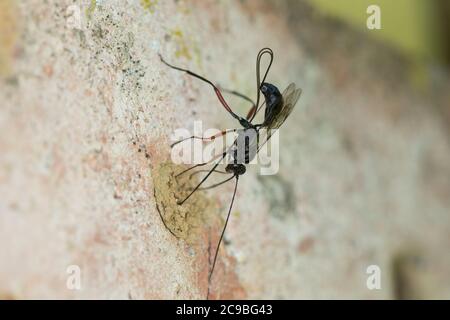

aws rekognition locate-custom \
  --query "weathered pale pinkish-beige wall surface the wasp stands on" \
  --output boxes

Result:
[0,1,450,299]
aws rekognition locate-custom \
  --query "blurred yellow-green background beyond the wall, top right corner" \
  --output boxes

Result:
[307,0,450,88]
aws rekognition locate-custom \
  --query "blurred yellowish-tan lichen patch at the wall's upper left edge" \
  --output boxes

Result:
[0,0,18,77]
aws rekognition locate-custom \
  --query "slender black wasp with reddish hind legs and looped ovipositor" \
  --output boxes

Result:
[160,48,302,296]
